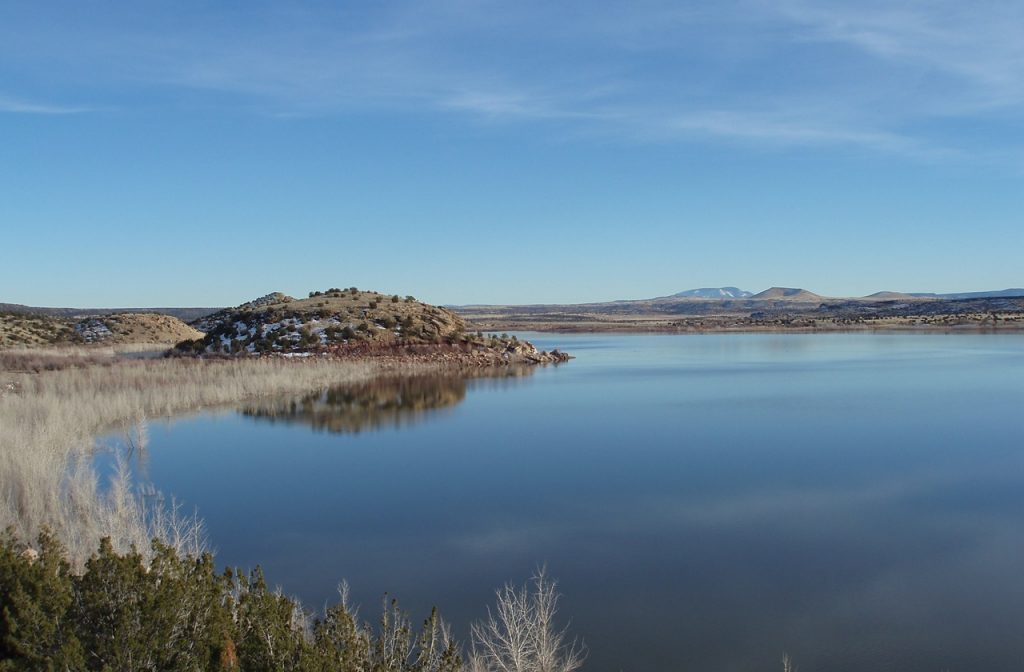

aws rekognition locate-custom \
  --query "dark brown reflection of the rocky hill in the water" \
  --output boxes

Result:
[240,369,529,433]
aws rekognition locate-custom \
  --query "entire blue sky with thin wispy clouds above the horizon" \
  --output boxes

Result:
[0,0,1024,306]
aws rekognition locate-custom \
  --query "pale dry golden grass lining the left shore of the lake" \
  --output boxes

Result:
[0,348,426,563]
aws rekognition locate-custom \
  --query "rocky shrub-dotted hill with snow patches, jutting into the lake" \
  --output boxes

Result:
[177,287,567,364]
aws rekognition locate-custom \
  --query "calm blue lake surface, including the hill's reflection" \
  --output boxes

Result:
[110,334,1024,672]
